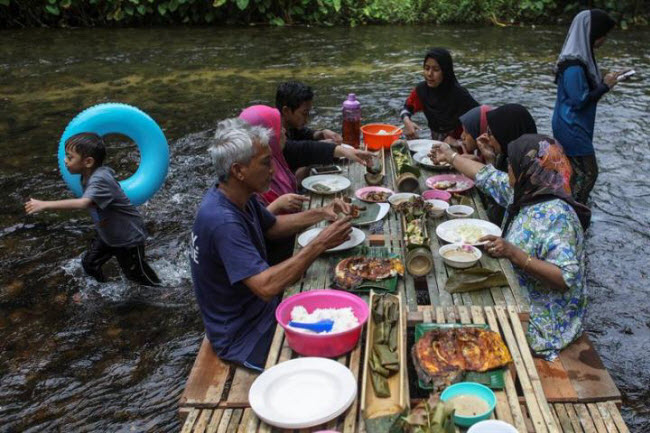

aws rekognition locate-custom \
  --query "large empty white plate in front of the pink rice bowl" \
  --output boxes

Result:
[248,358,357,429]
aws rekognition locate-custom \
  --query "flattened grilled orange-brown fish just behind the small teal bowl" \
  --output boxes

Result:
[411,327,512,389]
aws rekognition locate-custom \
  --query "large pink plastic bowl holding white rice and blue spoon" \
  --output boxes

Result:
[275,289,368,358]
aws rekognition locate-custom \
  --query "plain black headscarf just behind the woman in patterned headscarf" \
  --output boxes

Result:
[486,104,537,155]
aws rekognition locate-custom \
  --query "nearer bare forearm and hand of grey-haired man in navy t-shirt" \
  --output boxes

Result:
[242,217,352,301]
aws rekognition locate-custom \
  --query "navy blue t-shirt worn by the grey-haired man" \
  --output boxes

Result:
[190,187,278,364]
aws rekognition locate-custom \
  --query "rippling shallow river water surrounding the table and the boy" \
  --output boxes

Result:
[0,26,650,432]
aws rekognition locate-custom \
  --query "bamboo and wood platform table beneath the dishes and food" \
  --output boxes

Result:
[179,150,628,433]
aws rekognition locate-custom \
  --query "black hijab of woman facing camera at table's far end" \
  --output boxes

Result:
[415,48,478,133]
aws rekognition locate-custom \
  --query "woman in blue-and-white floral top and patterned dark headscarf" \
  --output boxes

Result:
[434,134,591,361]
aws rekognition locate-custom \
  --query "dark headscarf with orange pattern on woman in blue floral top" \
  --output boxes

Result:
[503,134,591,236]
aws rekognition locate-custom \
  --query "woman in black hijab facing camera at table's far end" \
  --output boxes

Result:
[400,48,479,140]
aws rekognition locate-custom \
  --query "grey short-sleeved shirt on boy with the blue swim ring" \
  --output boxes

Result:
[82,166,147,247]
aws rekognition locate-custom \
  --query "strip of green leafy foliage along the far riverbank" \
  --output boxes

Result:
[0,0,650,28]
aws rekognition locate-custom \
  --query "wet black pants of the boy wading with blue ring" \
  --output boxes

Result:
[81,237,160,286]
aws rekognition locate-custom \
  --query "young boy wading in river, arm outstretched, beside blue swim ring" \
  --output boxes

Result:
[25,133,160,286]
